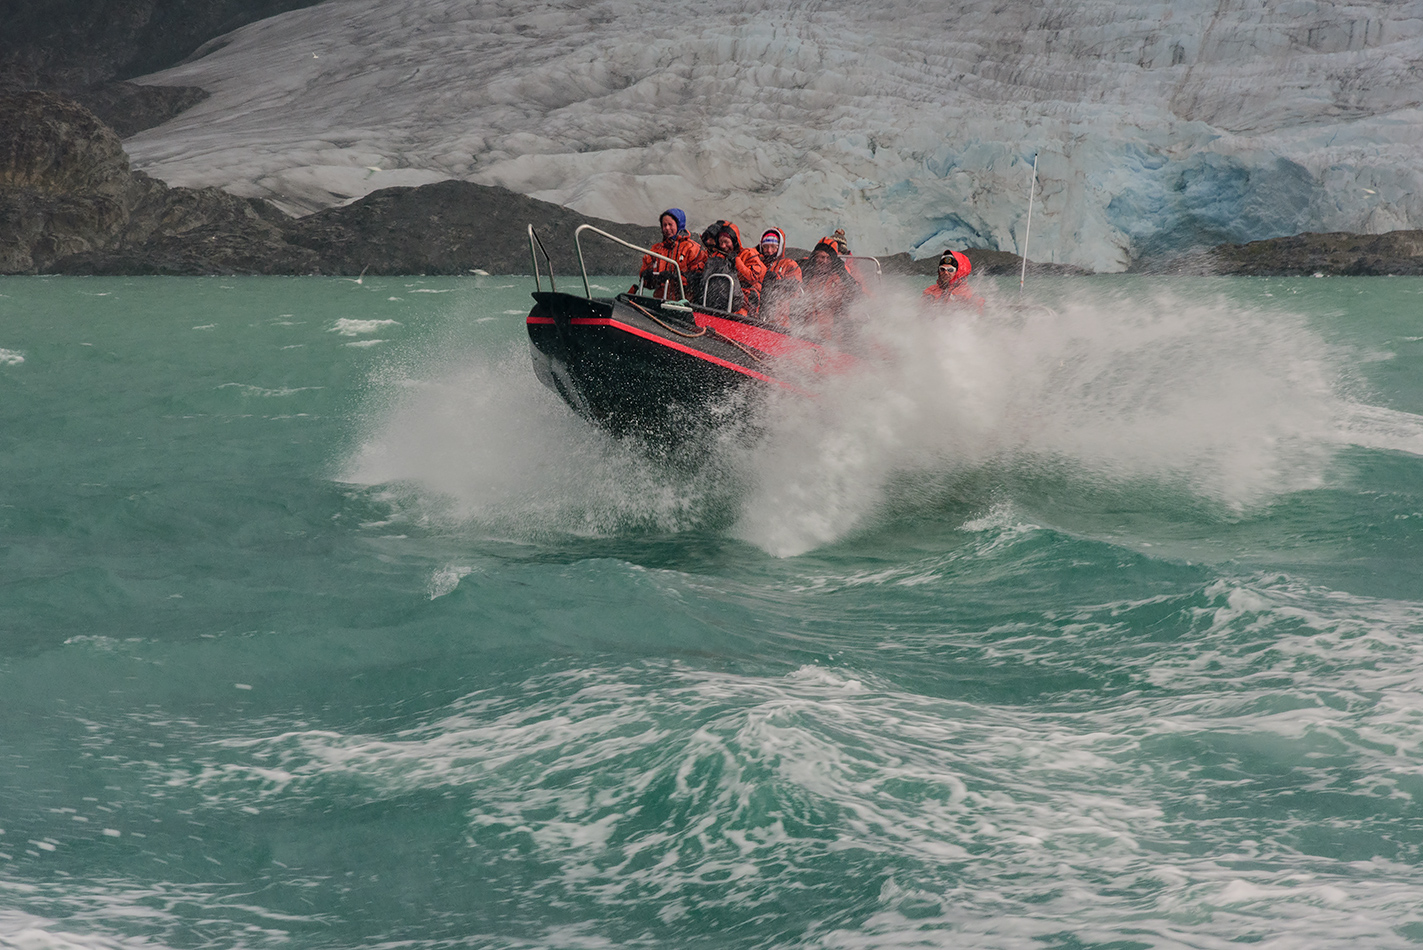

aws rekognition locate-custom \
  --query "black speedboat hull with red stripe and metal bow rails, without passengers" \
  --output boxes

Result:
[528,225,854,441]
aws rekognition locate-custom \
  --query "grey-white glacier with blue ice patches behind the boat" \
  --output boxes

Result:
[125,0,1423,272]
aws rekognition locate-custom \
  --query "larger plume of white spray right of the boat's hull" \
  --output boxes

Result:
[737,278,1342,555]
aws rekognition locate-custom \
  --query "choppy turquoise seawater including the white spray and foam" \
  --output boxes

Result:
[0,277,1423,950]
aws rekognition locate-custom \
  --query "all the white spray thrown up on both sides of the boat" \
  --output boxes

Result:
[346,284,1345,556]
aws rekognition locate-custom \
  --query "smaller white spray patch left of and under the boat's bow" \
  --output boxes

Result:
[334,341,734,539]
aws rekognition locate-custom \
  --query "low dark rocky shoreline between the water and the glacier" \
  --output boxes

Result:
[0,91,1423,276]
